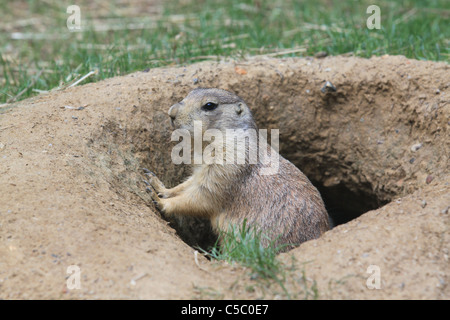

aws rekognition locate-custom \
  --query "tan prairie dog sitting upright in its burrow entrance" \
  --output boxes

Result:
[147,88,329,247]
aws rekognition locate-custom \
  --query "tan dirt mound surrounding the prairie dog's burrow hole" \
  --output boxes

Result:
[0,56,450,299]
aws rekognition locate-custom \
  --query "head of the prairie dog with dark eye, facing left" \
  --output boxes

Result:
[169,88,256,133]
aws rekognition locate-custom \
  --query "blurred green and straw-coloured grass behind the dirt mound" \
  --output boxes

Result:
[0,0,450,103]
